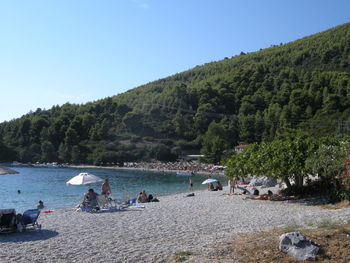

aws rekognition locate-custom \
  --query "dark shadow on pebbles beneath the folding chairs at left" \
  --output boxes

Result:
[0,229,58,244]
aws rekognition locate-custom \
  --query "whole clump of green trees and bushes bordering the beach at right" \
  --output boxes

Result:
[225,136,350,201]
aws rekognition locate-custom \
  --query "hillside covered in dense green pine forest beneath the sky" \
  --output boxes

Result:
[0,23,350,164]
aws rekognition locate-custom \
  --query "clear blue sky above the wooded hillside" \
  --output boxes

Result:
[0,0,350,122]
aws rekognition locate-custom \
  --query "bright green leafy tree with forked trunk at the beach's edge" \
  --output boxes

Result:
[227,137,315,191]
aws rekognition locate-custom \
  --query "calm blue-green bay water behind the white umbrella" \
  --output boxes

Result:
[0,167,224,213]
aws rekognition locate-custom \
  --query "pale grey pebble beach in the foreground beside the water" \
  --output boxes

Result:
[0,189,350,262]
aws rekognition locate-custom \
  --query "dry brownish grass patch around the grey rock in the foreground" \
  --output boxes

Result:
[178,221,350,263]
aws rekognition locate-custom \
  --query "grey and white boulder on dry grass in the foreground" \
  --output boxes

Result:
[279,232,319,261]
